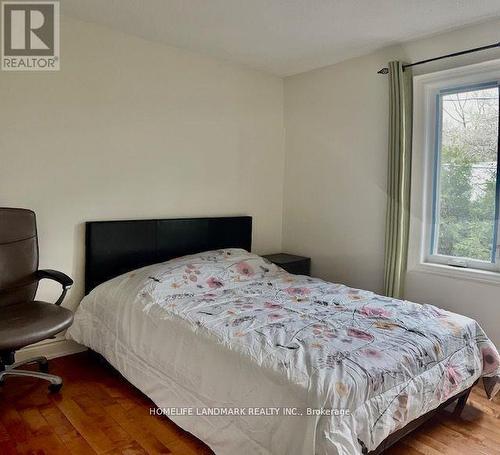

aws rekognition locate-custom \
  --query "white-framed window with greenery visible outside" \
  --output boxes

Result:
[408,60,500,284]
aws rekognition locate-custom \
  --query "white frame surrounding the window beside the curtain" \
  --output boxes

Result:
[408,60,500,285]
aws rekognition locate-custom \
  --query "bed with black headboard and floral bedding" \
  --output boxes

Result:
[67,217,500,455]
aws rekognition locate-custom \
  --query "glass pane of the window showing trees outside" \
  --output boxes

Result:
[433,87,499,262]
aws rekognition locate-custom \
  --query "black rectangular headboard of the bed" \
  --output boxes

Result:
[85,216,252,294]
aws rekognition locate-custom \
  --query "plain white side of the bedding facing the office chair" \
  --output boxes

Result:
[67,268,320,455]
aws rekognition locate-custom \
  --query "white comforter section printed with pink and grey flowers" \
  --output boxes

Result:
[70,249,500,454]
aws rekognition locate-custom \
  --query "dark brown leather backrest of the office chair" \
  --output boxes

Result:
[0,207,38,307]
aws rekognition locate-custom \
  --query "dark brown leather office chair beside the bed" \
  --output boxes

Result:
[0,208,73,392]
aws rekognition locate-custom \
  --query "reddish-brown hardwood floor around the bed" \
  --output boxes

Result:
[0,353,500,455]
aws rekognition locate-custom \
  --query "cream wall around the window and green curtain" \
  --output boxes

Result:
[283,16,500,345]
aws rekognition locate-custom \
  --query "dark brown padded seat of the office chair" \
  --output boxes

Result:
[0,300,73,351]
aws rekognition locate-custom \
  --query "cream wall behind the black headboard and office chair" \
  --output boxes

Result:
[0,18,284,356]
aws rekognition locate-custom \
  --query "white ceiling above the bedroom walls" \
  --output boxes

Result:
[61,0,500,76]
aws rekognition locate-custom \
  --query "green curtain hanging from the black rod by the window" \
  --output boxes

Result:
[384,62,412,298]
